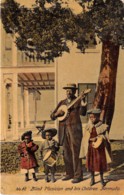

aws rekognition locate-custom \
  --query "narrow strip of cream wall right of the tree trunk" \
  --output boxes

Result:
[110,50,124,139]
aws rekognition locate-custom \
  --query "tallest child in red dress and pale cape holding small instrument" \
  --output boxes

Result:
[80,109,111,187]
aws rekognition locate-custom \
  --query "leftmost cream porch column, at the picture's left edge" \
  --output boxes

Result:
[0,73,7,141]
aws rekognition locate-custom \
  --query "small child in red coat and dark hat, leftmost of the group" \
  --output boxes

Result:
[18,131,38,181]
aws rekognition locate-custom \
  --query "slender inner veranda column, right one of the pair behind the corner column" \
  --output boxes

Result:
[24,89,30,127]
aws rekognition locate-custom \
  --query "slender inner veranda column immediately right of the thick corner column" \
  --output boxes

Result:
[20,86,24,128]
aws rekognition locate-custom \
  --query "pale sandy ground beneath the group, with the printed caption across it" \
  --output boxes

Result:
[1,141,124,195]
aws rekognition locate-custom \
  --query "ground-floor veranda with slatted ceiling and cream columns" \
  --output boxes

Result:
[1,66,56,140]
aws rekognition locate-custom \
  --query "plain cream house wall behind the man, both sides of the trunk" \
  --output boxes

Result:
[56,44,124,139]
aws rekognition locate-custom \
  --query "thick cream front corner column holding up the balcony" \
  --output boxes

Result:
[12,73,19,140]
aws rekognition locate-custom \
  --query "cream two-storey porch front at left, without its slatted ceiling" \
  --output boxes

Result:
[0,25,55,141]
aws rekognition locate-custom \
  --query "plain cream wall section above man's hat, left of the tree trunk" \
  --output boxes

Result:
[58,44,101,100]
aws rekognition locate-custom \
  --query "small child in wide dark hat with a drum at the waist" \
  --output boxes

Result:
[41,128,59,182]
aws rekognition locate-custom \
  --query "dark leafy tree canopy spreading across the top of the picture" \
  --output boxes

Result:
[1,0,124,60]
